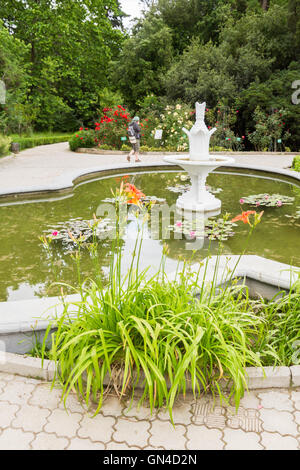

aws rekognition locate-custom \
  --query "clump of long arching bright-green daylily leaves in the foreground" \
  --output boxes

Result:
[44,206,264,416]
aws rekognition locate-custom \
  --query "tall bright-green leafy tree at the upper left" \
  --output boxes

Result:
[0,0,123,128]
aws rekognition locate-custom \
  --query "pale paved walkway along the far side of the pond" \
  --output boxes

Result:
[0,143,293,195]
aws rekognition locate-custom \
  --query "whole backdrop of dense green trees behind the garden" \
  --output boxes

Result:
[0,0,300,151]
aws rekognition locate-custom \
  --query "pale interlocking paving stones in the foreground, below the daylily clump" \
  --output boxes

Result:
[0,373,300,450]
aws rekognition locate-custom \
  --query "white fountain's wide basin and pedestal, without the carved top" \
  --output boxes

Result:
[164,155,234,217]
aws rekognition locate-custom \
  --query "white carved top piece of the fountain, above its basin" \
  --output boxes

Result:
[182,102,217,160]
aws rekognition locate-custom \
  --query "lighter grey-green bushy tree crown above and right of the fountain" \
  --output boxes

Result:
[164,5,293,106]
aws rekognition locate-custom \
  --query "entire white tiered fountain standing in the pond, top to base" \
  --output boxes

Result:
[164,103,234,217]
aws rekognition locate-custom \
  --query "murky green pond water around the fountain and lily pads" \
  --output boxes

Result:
[0,170,300,301]
